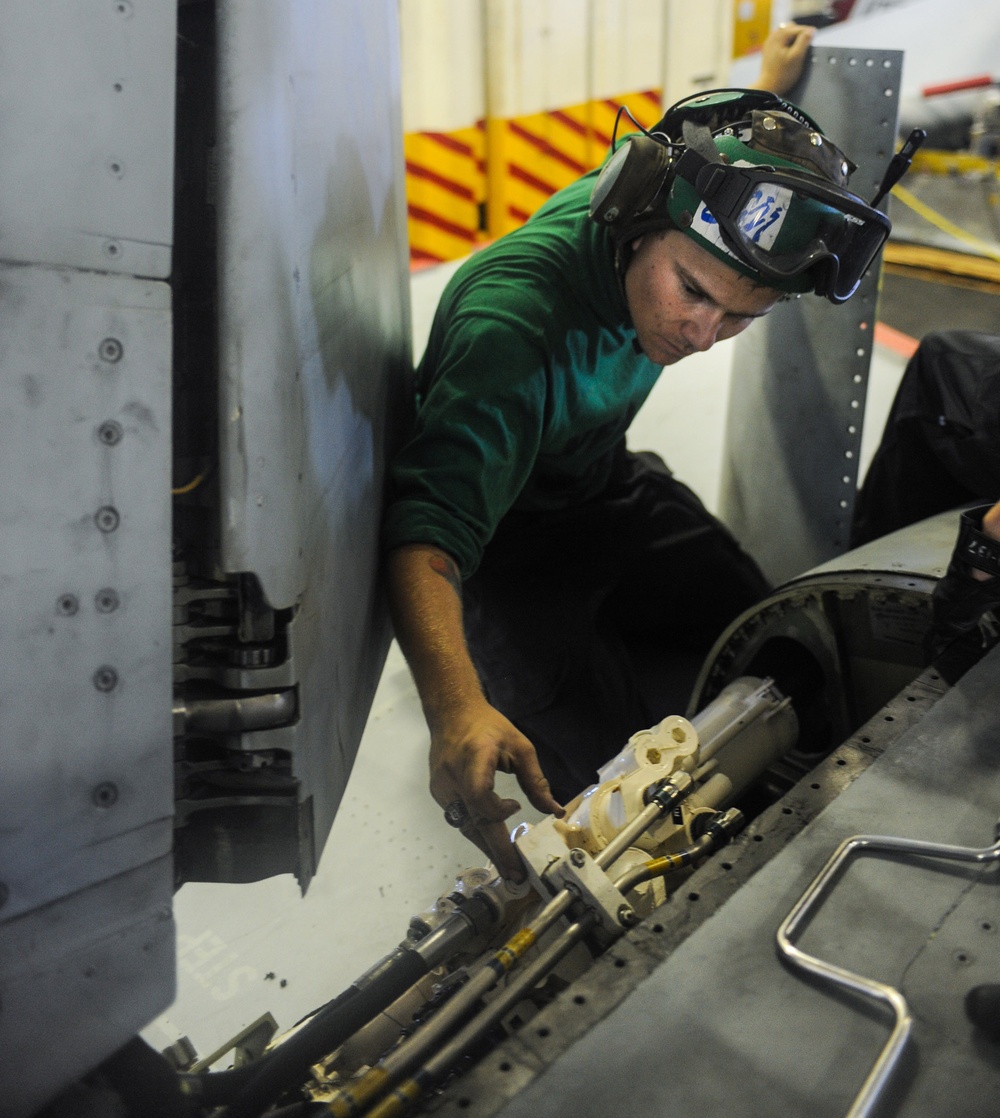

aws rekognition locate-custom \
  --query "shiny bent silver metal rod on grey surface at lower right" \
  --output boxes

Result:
[777,822,1000,1118]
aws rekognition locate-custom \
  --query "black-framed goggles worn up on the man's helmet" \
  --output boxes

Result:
[676,148,891,303]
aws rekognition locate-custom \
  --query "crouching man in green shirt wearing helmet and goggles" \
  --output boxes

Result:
[384,81,888,878]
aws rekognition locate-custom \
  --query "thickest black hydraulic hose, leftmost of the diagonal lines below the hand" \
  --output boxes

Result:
[214,890,498,1118]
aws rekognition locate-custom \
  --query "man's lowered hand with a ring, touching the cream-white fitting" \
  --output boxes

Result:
[431,699,563,881]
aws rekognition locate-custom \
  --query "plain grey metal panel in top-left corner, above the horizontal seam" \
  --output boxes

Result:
[0,0,177,277]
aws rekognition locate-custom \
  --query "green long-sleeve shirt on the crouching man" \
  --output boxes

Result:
[384,174,662,577]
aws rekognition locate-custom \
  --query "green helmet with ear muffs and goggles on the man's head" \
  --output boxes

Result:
[589,89,894,303]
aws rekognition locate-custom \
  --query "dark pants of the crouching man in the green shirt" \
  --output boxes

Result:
[463,447,768,802]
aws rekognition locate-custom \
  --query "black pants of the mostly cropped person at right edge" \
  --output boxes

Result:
[851,330,1000,547]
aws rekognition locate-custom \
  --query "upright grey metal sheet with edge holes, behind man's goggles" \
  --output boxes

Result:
[720,47,903,582]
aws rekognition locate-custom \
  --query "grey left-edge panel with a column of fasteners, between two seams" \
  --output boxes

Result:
[0,268,172,917]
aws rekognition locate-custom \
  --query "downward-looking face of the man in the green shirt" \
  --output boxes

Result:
[625,229,781,364]
